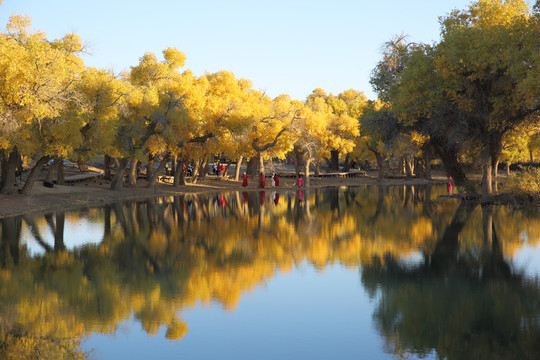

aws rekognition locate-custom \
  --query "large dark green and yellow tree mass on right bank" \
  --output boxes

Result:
[363,0,540,200]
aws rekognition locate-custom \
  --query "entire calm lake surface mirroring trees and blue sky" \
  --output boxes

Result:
[0,186,540,359]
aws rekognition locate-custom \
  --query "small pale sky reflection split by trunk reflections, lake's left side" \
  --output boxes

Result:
[21,216,103,256]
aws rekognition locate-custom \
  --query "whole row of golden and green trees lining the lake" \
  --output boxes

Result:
[0,0,540,194]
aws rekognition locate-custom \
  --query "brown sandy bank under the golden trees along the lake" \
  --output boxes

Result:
[0,169,456,218]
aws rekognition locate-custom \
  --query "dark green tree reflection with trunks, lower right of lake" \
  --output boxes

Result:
[362,203,540,359]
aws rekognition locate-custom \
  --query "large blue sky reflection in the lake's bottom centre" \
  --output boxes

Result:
[83,261,402,360]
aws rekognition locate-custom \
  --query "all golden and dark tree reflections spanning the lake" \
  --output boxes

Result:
[0,186,540,358]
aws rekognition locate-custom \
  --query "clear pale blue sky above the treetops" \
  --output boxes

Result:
[0,0,470,100]
